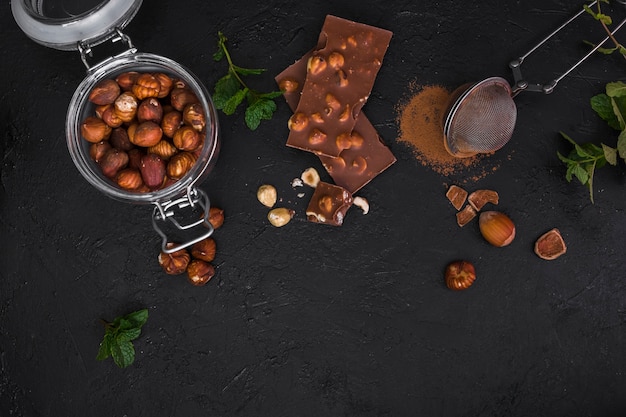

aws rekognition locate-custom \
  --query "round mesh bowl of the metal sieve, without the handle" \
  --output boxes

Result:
[444,77,517,157]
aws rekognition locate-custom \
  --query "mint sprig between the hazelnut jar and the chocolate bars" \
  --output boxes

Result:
[213,32,283,130]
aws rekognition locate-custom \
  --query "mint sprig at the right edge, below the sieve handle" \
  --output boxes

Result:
[557,81,626,203]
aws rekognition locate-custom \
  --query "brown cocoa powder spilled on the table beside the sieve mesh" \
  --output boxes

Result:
[397,83,496,181]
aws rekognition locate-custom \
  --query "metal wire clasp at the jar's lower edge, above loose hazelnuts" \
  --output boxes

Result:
[152,188,214,253]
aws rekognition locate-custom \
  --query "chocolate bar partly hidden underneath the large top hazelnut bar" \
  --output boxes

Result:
[276,17,396,194]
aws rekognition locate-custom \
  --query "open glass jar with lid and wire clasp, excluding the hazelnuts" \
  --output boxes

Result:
[11,0,220,253]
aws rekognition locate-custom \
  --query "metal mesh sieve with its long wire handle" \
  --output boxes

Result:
[443,0,626,158]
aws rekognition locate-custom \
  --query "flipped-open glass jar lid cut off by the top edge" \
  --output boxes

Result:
[11,0,142,51]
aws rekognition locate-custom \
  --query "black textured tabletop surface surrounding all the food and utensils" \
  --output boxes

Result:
[0,0,626,417]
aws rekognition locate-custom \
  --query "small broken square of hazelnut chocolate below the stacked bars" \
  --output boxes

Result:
[306,181,353,226]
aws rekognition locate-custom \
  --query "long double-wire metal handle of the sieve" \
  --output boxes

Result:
[509,0,626,97]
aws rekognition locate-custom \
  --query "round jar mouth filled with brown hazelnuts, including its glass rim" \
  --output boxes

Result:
[66,53,219,203]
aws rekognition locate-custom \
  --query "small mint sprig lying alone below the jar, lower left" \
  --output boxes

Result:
[96,309,148,368]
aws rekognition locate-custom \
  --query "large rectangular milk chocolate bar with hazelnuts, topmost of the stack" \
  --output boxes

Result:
[287,15,392,157]
